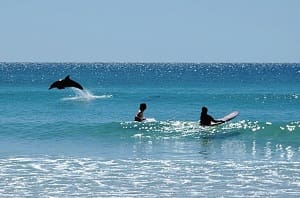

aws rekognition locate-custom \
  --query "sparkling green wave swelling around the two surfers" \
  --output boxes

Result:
[121,120,300,139]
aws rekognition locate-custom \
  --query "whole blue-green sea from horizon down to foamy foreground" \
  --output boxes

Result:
[0,63,300,197]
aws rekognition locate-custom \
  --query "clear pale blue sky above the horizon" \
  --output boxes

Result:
[0,0,300,63]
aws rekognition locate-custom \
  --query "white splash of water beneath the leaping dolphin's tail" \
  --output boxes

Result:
[62,88,112,101]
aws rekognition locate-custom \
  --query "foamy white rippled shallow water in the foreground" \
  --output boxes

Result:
[0,157,300,197]
